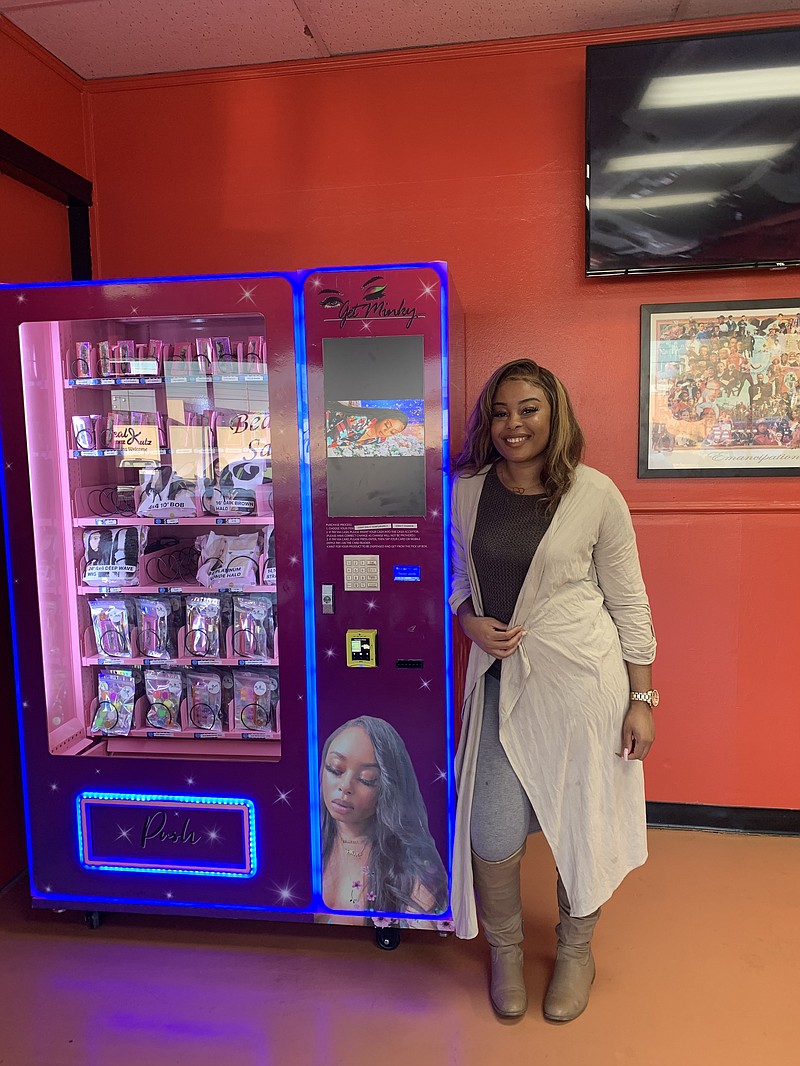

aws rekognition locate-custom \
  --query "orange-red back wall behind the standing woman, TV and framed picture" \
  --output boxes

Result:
[83,16,800,808]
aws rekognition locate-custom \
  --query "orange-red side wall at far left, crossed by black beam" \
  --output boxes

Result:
[0,18,89,887]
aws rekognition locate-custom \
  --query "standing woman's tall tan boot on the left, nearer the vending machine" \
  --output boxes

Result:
[473,844,528,1018]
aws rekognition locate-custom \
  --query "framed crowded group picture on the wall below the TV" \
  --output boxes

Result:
[639,297,800,478]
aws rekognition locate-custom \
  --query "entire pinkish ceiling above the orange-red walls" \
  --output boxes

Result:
[0,0,800,79]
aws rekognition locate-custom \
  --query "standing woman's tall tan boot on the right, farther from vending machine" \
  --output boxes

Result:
[544,874,601,1021]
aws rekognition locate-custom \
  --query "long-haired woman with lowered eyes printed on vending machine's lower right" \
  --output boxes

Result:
[320,715,454,915]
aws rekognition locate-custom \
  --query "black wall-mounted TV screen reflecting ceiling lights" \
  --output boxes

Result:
[586,28,800,276]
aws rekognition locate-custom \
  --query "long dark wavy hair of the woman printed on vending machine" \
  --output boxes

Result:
[320,715,454,915]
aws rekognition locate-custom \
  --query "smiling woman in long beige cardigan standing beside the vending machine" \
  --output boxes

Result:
[450,359,658,1021]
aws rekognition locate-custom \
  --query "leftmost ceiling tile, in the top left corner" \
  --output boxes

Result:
[0,0,320,78]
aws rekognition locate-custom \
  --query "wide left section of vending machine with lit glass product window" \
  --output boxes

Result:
[0,275,314,924]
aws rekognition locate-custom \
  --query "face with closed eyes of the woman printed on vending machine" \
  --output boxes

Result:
[322,726,381,836]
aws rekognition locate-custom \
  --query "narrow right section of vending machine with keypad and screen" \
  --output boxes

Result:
[303,263,458,948]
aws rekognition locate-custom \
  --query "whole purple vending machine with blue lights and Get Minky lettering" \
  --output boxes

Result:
[0,263,455,948]
